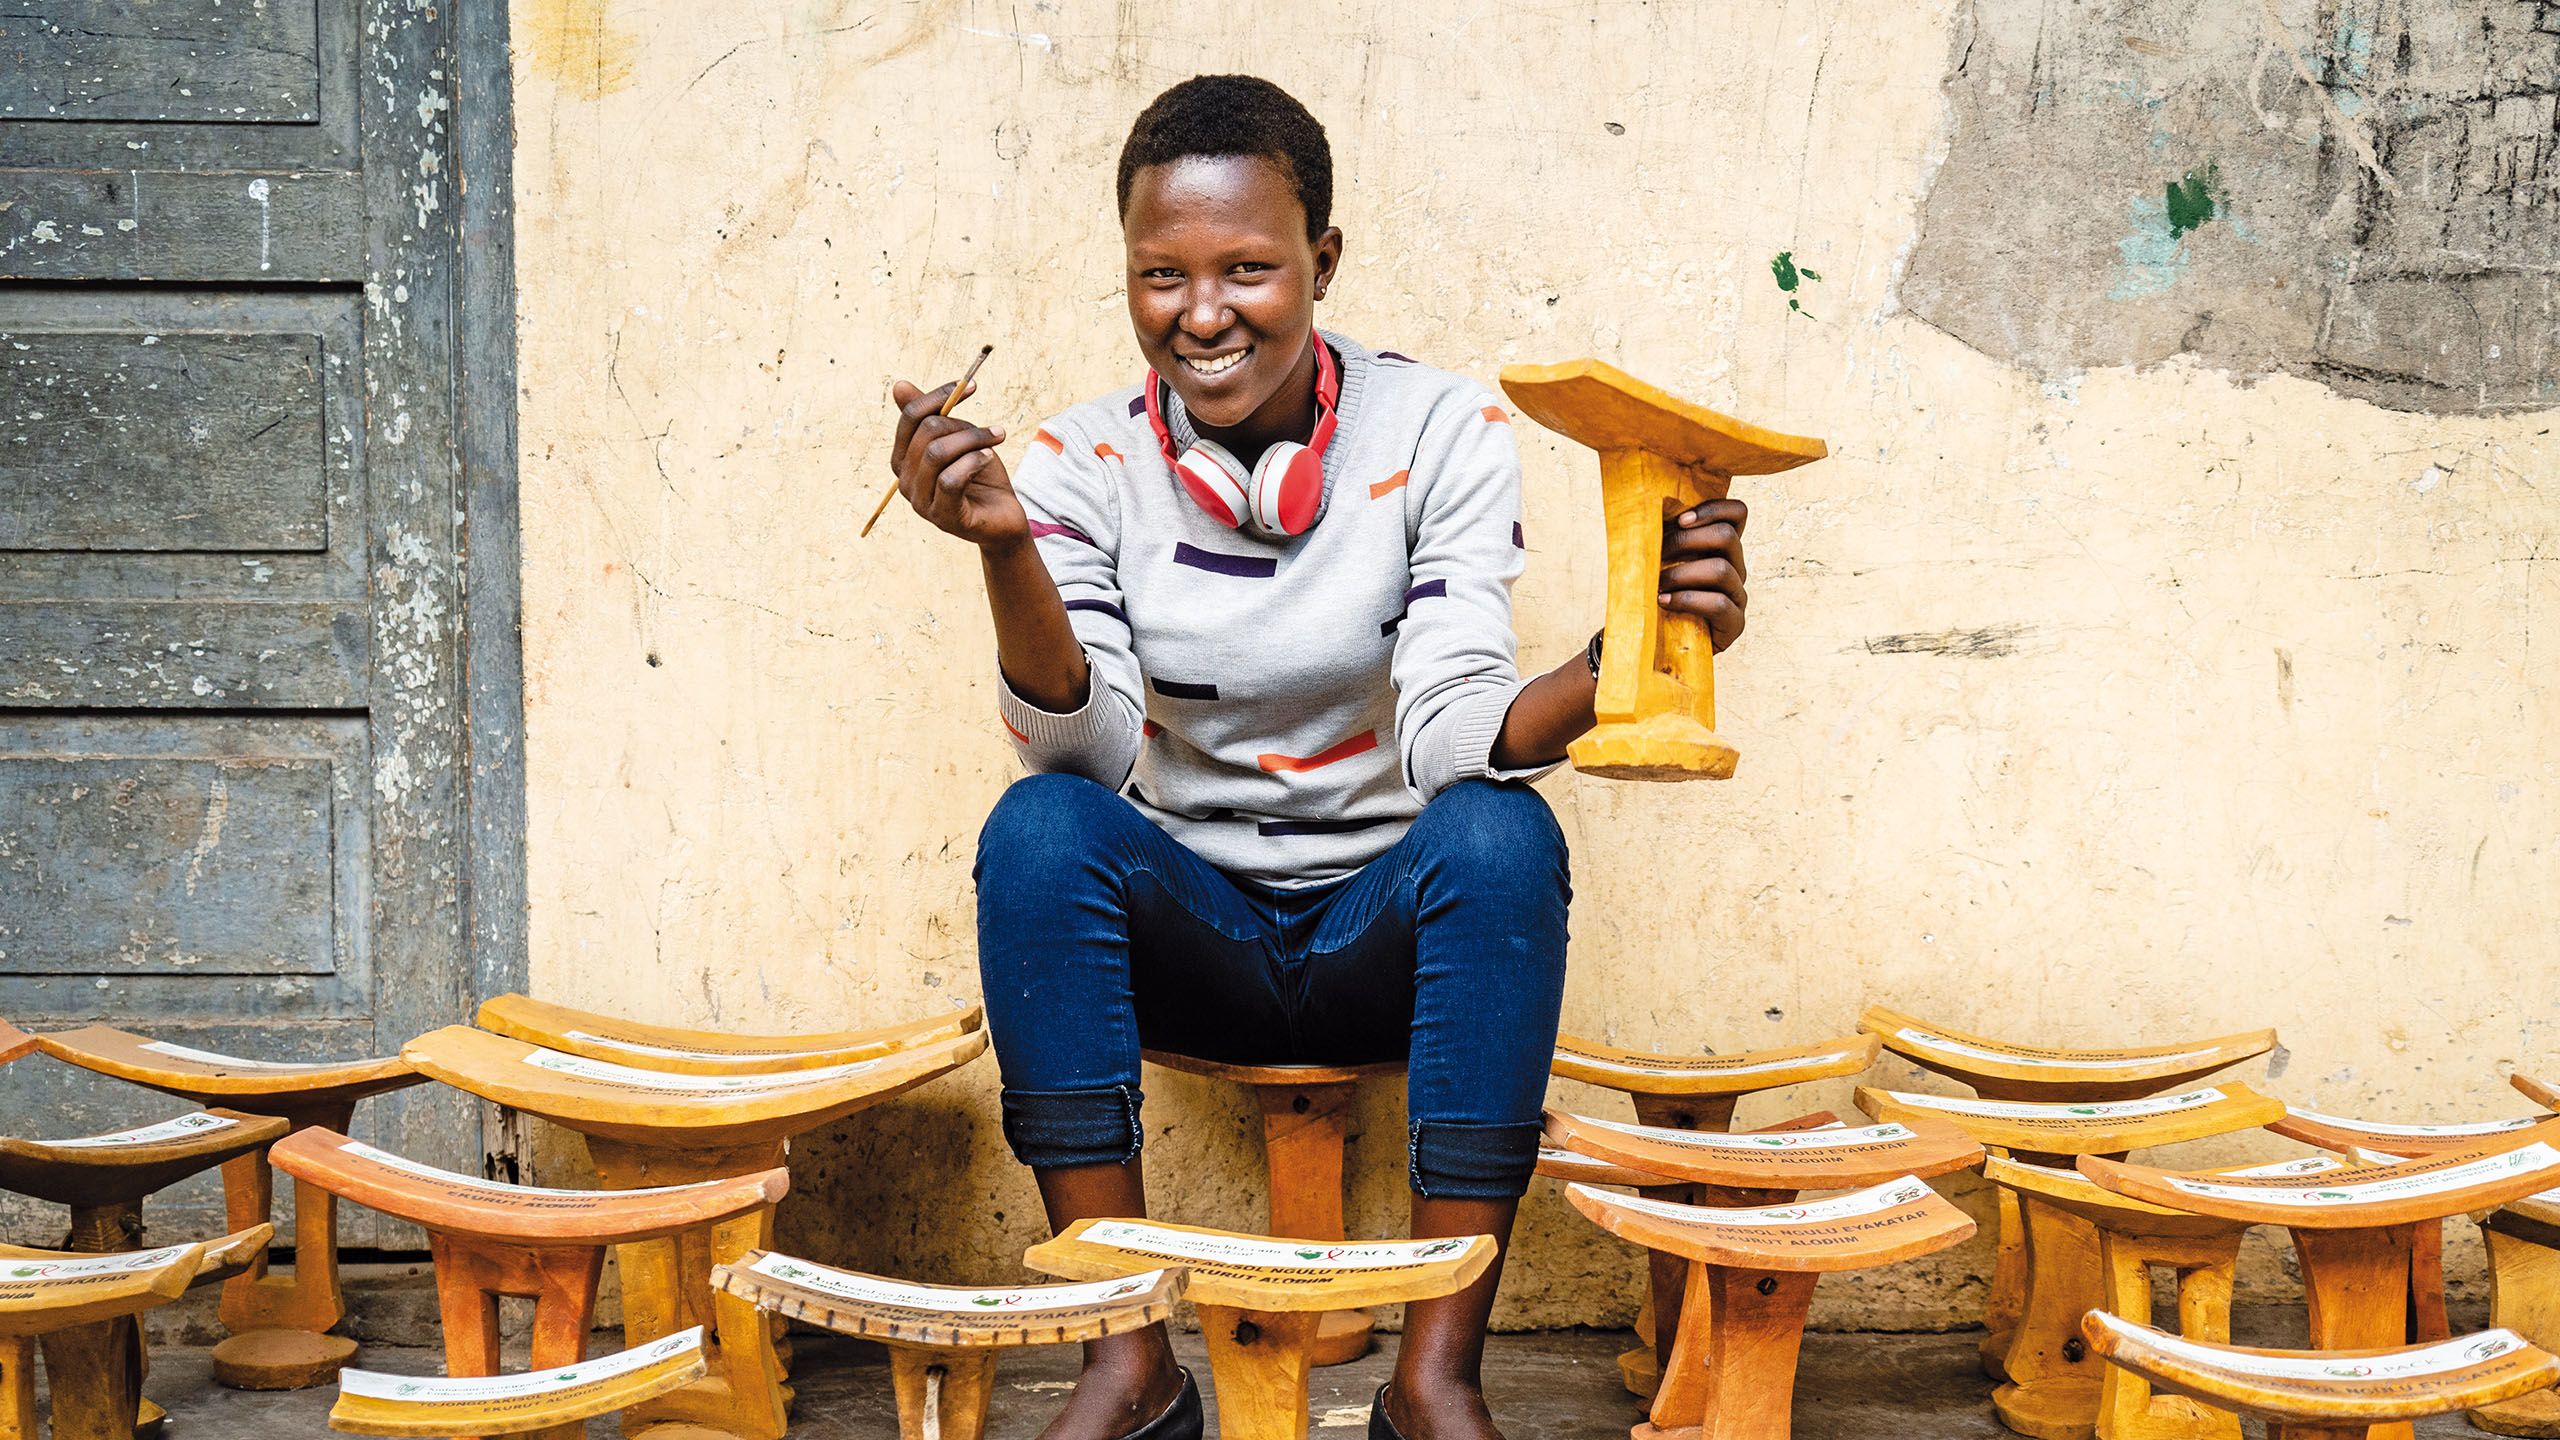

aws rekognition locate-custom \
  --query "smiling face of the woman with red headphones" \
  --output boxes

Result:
[1121,156,1341,445]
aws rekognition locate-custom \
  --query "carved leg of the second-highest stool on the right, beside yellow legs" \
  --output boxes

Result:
[1992,1197,2107,1440]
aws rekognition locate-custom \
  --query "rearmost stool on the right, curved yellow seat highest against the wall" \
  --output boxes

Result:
[1859,1004,2276,1381]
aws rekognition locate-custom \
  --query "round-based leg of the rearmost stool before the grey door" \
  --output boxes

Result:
[212,1102,356,1389]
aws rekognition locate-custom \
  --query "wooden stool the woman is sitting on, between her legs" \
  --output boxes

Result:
[1144,1051,1405,1366]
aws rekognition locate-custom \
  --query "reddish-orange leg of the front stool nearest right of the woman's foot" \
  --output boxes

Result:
[1628,1263,1820,1440]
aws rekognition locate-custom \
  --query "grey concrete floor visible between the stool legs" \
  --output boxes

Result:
[80,1317,2481,1440]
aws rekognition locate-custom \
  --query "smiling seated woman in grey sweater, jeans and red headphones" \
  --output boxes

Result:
[891,74,1743,1440]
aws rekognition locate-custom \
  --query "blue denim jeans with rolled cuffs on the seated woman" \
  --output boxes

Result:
[973,774,1572,1199]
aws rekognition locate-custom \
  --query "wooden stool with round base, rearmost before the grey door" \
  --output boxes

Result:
[36,1025,428,1389]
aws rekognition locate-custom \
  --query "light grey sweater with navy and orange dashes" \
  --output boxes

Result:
[998,333,1541,887]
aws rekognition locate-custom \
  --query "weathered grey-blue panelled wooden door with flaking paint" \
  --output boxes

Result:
[0,0,512,1245]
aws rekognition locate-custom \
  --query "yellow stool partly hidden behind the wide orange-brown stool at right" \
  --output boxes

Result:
[1981,1156,2345,1440]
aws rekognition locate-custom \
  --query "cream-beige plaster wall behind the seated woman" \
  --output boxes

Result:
[515,0,2560,1325]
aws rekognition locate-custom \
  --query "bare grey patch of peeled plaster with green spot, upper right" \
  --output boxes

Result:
[1902,0,2560,415]
